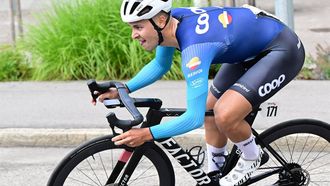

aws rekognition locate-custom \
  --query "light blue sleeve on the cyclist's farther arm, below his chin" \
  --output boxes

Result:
[126,46,175,92]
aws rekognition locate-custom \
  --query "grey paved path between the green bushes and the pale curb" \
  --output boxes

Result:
[0,80,330,129]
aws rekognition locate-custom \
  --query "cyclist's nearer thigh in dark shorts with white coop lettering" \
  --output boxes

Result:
[230,26,305,106]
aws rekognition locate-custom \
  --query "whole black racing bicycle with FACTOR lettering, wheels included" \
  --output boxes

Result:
[48,80,330,186]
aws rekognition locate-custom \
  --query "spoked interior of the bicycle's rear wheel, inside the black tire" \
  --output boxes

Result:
[256,133,330,185]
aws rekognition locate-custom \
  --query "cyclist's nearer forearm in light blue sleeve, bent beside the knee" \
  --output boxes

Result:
[150,93,207,139]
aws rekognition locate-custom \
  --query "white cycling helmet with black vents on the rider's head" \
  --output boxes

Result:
[120,0,172,23]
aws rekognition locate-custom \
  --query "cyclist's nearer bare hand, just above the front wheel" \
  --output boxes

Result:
[112,128,153,147]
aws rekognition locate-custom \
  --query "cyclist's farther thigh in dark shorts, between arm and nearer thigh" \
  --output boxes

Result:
[210,63,245,99]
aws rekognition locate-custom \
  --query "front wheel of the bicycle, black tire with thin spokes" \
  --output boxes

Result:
[47,135,175,186]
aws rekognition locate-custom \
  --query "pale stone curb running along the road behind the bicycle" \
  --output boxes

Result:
[0,128,330,152]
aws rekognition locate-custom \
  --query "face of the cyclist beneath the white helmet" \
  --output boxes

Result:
[129,20,158,51]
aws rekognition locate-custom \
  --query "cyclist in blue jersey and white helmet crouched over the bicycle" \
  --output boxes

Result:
[94,0,305,185]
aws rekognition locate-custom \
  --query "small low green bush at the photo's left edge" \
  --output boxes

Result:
[0,46,31,81]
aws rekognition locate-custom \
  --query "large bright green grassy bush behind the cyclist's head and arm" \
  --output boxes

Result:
[23,0,191,80]
